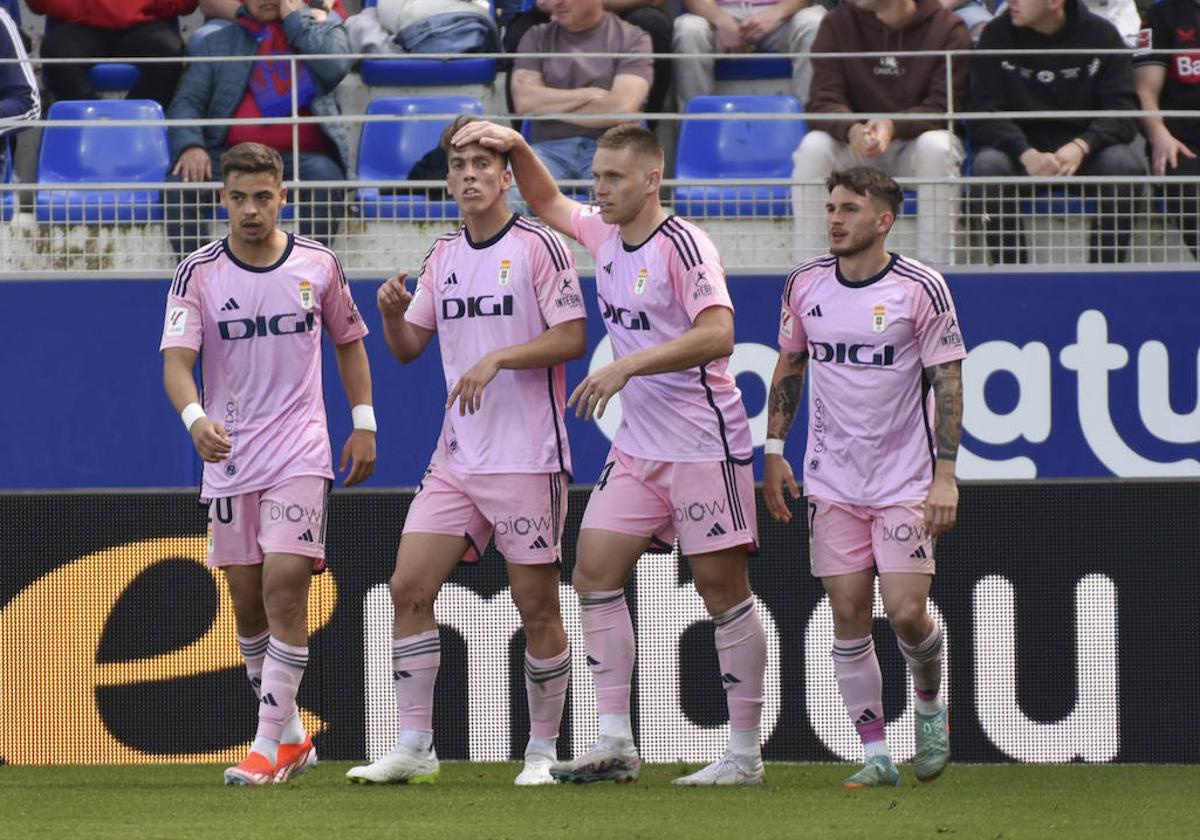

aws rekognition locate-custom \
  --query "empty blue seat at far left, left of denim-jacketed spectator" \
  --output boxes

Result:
[35,100,170,224]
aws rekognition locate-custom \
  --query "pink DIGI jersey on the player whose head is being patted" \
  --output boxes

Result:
[406,215,587,473]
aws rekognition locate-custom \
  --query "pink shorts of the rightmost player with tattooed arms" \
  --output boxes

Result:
[806,496,934,577]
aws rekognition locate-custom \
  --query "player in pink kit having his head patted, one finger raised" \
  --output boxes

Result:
[347,116,587,785]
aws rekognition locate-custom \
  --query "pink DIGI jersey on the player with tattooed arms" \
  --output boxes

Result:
[779,254,966,506]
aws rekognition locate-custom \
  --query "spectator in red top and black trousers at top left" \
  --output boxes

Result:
[29,0,197,108]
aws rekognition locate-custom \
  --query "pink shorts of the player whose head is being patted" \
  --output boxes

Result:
[404,464,566,564]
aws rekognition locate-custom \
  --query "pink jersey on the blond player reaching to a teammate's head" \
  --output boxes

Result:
[571,205,751,463]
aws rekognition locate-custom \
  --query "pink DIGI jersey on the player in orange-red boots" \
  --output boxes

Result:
[161,235,367,498]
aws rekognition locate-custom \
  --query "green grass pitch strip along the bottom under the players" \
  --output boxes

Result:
[0,762,1200,840]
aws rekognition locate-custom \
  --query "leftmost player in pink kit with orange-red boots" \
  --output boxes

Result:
[162,143,376,785]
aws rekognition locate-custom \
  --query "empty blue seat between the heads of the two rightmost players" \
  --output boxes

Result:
[674,95,806,216]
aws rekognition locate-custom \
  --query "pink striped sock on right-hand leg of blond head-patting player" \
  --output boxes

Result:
[713,595,767,755]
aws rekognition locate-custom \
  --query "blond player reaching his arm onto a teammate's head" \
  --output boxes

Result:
[454,118,767,785]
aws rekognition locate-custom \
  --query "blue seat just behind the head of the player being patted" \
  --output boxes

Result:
[359,96,484,218]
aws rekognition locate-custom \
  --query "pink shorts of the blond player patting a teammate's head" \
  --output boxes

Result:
[581,449,758,556]
